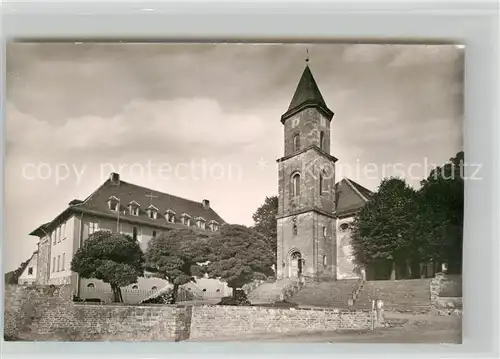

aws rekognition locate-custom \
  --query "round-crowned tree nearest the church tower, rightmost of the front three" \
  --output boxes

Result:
[206,225,274,298]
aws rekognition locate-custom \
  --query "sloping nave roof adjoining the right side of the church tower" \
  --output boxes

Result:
[335,178,372,217]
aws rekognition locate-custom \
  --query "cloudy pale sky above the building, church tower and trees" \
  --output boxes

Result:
[3,43,464,271]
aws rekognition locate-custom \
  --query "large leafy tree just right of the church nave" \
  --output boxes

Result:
[351,178,419,279]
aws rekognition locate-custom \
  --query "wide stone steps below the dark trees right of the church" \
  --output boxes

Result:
[353,279,431,313]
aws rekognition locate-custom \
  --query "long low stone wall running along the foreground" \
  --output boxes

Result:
[4,286,376,341]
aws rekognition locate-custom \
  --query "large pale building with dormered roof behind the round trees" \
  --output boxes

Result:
[29,173,227,301]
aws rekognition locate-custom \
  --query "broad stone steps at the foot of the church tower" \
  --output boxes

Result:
[291,279,357,309]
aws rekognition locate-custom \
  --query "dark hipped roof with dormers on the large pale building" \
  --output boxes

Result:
[30,177,225,236]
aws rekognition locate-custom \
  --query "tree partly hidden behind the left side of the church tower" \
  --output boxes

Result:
[252,196,278,258]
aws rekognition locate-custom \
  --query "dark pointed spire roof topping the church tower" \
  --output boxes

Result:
[283,65,333,121]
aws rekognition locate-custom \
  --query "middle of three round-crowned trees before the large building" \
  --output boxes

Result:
[146,228,209,304]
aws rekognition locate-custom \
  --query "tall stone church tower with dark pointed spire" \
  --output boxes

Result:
[277,65,337,279]
